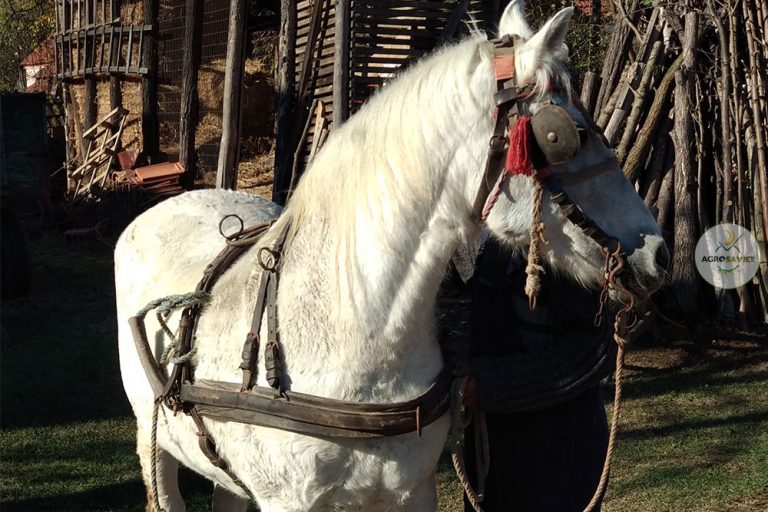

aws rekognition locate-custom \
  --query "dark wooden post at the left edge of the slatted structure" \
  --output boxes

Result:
[272,0,296,204]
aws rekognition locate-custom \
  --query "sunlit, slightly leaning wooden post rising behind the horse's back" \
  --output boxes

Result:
[216,0,248,190]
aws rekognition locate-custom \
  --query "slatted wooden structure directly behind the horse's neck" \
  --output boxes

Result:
[273,0,500,203]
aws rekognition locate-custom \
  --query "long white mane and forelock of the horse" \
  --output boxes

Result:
[268,34,570,324]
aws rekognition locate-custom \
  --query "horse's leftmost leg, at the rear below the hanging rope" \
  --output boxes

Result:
[136,422,186,512]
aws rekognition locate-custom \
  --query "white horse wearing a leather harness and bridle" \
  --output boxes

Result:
[115,0,666,512]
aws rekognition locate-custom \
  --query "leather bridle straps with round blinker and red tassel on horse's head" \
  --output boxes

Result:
[472,35,619,252]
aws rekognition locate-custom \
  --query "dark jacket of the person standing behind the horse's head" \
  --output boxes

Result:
[470,239,615,414]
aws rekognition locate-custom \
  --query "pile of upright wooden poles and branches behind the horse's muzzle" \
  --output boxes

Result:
[582,0,768,324]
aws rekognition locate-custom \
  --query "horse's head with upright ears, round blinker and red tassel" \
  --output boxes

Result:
[476,0,669,297]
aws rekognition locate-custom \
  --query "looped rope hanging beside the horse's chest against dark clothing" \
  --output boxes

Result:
[451,376,490,512]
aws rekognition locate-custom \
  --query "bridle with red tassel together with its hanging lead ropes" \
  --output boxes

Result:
[460,35,635,512]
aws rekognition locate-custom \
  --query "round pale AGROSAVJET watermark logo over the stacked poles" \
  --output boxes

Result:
[695,224,760,288]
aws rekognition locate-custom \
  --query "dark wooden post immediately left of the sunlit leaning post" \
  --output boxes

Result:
[179,0,204,186]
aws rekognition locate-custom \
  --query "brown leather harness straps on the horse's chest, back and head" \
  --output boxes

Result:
[128,36,628,494]
